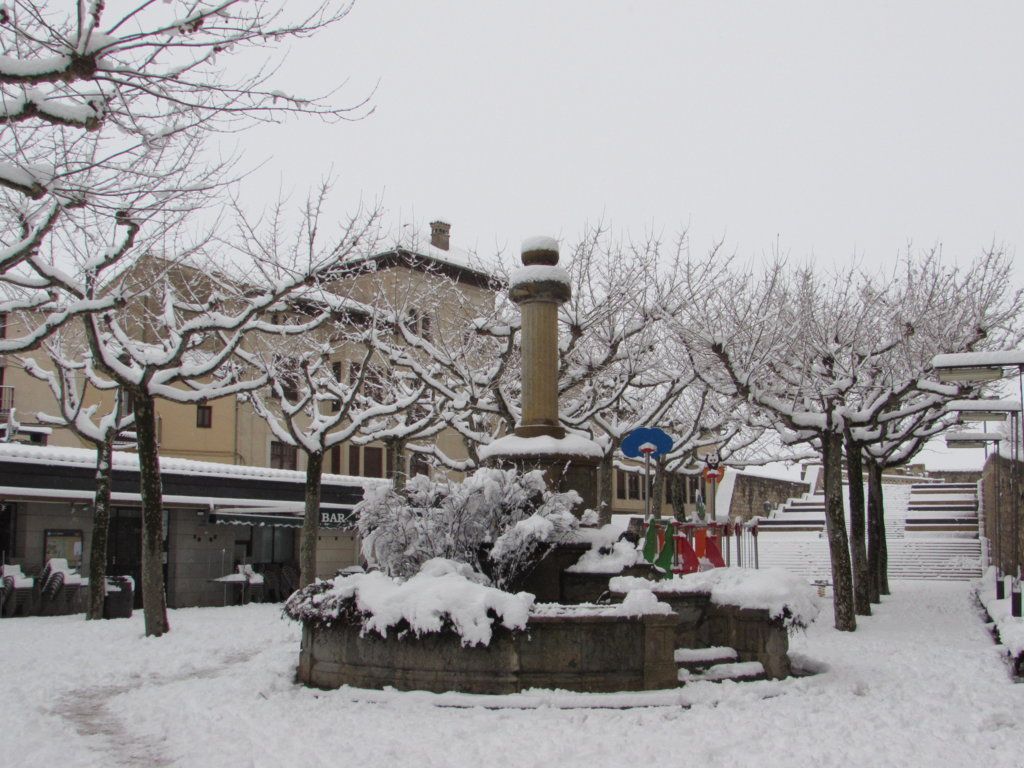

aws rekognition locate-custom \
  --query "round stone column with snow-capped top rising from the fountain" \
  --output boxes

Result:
[480,238,602,512]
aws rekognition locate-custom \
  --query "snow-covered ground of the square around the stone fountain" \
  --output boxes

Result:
[0,582,1024,768]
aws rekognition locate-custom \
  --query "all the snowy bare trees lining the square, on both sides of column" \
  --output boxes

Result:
[0,0,1021,635]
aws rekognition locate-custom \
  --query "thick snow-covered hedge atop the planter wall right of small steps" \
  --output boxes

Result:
[609,568,819,629]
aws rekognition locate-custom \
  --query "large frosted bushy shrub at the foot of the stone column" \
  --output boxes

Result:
[355,468,580,586]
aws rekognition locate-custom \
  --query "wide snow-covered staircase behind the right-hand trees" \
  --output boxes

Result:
[758,482,981,582]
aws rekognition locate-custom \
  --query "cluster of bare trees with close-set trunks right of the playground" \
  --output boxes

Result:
[678,251,1024,630]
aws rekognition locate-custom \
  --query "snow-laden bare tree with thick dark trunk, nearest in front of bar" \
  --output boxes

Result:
[74,205,371,635]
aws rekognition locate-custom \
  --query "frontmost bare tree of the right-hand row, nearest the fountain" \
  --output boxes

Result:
[686,261,898,631]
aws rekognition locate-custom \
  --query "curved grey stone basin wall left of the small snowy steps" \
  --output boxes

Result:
[298,614,678,694]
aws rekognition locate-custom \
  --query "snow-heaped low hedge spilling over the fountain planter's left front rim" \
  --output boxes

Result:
[285,558,534,645]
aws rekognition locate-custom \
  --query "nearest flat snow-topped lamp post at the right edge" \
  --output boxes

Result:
[932,349,1024,578]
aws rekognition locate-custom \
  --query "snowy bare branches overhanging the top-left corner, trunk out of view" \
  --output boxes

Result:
[0,0,367,351]
